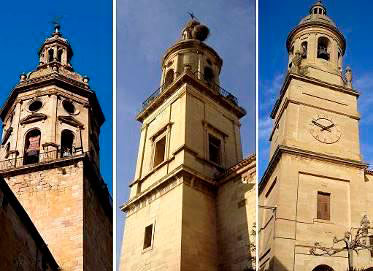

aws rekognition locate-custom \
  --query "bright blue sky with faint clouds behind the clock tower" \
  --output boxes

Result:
[258,0,373,176]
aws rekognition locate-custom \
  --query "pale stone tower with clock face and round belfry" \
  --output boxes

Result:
[258,1,373,271]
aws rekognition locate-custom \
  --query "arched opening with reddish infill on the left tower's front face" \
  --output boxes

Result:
[23,129,41,165]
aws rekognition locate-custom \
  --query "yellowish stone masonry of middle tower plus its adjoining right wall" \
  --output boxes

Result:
[120,18,256,271]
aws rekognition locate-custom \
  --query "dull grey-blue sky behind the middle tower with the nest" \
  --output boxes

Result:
[117,0,255,266]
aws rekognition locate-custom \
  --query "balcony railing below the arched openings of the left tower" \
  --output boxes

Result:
[0,150,83,171]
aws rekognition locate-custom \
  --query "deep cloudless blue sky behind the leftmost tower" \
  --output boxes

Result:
[0,0,113,191]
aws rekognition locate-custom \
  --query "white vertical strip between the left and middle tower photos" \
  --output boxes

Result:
[113,0,118,271]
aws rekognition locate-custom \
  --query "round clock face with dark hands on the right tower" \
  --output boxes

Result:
[310,116,342,144]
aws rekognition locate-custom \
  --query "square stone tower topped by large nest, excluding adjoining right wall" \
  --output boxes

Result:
[120,20,246,271]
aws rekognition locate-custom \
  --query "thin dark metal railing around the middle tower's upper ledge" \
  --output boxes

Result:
[142,71,238,110]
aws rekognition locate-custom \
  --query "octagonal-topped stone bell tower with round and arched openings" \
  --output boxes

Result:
[0,25,112,271]
